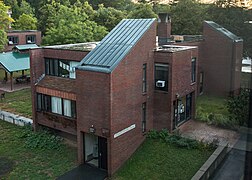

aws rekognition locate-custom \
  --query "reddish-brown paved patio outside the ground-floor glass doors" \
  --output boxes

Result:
[179,120,240,147]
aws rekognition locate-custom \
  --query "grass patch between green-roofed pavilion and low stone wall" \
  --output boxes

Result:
[0,88,32,118]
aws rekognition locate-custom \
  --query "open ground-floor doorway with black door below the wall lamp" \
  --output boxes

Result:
[83,133,108,170]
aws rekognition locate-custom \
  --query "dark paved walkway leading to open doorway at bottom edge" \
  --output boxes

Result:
[57,164,107,180]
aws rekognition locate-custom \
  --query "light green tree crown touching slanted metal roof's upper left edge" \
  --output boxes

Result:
[94,4,126,31]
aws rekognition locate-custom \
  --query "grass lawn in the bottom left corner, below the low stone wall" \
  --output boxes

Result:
[0,120,77,179]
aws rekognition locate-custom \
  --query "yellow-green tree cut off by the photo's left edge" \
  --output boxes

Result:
[0,1,13,51]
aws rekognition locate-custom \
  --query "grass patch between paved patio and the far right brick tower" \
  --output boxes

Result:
[196,95,229,115]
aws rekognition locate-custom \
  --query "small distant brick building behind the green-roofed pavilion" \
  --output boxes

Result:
[4,30,41,51]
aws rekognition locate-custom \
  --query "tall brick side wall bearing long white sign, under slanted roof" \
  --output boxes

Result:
[109,20,156,173]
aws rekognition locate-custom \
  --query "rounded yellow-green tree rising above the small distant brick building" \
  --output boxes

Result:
[13,14,37,30]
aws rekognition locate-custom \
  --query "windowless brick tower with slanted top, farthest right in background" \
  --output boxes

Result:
[200,23,242,96]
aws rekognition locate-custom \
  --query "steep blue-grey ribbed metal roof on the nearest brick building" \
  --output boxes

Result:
[78,19,155,73]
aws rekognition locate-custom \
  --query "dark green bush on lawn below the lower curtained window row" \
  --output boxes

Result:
[18,126,63,149]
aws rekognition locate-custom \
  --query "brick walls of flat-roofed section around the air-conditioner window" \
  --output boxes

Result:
[153,48,198,131]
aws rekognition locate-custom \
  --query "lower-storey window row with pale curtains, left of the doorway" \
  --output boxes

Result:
[37,93,76,118]
